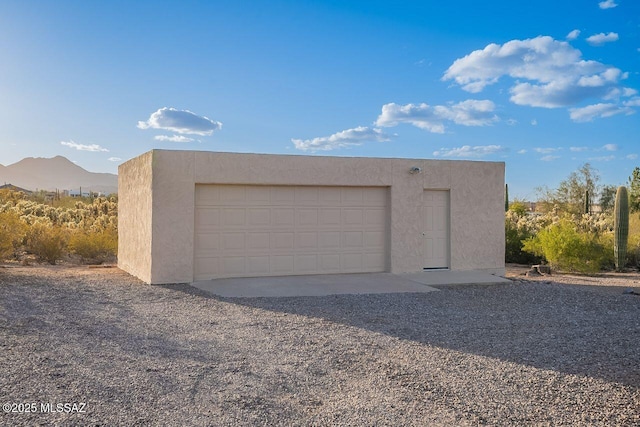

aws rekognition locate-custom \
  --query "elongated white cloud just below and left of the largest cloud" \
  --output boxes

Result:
[376,99,498,133]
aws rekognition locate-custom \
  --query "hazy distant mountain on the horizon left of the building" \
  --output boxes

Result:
[0,156,118,194]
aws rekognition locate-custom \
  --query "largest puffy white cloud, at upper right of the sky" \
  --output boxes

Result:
[442,36,628,114]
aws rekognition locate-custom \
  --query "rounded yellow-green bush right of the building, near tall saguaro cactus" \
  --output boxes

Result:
[523,219,606,273]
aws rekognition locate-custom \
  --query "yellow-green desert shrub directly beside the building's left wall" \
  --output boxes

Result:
[69,227,118,263]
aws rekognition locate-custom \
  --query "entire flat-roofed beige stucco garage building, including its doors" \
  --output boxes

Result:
[118,150,504,284]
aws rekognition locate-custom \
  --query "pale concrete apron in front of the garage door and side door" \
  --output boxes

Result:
[191,270,511,298]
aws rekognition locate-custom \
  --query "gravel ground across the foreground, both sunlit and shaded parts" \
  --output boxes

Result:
[0,266,640,426]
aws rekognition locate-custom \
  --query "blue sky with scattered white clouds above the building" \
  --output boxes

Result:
[0,0,640,199]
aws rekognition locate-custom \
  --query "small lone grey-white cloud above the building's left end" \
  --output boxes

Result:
[138,107,222,136]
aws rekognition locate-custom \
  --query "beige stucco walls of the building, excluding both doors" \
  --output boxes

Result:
[119,150,504,283]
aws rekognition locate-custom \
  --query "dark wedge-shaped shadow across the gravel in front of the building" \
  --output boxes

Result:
[191,283,640,387]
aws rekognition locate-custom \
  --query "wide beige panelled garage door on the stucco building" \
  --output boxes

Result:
[194,185,388,280]
